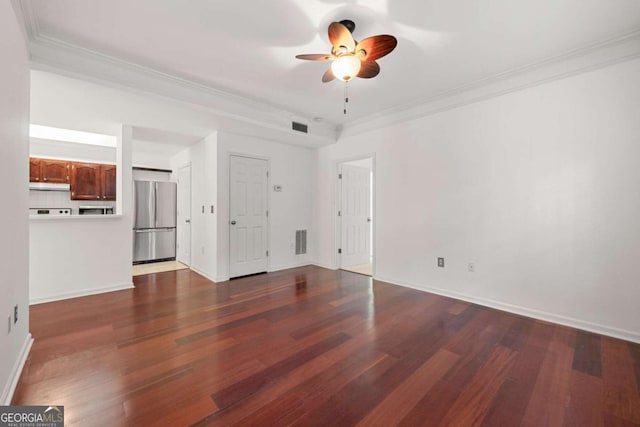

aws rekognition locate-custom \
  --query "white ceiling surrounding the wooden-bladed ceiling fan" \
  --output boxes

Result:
[18,0,640,132]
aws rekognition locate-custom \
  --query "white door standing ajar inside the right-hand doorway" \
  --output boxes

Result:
[340,164,371,267]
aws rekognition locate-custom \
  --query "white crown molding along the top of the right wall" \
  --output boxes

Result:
[338,30,640,139]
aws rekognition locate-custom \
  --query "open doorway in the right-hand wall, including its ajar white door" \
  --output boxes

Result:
[337,156,375,276]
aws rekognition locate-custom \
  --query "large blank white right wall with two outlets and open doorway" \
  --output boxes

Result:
[314,60,640,341]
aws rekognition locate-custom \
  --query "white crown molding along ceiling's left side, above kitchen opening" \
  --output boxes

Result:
[18,0,337,147]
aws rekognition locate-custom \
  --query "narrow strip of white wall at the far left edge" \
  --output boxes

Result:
[0,1,31,405]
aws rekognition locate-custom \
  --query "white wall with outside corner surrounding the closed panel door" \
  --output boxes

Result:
[171,131,315,282]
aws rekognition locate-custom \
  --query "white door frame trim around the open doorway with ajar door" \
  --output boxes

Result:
[333,153,378,278]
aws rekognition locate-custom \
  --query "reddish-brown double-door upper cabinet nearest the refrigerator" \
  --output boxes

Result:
[71,162,116,200]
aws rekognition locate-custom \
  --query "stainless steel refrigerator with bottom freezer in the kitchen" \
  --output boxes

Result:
[133,181,176,264]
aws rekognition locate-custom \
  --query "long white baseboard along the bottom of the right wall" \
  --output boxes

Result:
[374,276,640,343]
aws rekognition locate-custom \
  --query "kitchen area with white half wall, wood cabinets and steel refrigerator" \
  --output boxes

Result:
[29,121,188,304]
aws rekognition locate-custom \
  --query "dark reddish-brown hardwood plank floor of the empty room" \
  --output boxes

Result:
[13,267,640,427]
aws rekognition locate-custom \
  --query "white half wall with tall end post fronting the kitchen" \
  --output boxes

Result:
[26,126,133,303]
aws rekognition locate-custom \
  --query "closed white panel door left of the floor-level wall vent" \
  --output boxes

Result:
[229,156,269,277]
